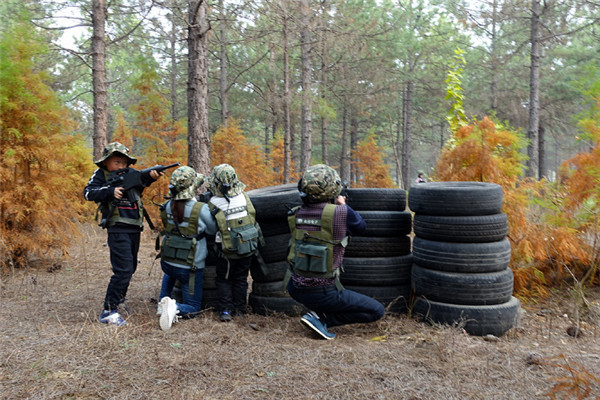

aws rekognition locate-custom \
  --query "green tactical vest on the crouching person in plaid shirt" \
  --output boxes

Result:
[287,204,348,290]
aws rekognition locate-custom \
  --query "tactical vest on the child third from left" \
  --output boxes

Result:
[208,193,261,259]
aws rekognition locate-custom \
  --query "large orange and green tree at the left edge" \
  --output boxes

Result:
[0,24,94,270]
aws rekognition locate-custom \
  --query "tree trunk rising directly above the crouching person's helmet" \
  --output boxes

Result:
[300,0,312,171]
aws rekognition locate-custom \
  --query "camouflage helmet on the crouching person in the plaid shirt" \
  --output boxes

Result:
[300,164,342,203]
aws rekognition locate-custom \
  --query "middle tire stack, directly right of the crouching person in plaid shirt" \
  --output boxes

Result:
[340,188,413,313]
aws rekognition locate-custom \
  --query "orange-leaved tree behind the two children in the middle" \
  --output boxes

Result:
[210,118,277,190]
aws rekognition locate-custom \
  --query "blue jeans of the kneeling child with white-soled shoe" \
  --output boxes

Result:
[160,260,204,317]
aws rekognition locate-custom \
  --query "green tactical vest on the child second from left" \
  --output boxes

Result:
[160,202,204,269]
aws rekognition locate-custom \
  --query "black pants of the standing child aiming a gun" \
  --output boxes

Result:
[104,232,140,310]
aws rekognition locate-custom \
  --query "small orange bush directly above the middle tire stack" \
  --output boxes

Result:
[352,134,394,188]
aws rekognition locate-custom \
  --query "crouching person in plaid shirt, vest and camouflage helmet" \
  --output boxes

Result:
[287,164,385,340]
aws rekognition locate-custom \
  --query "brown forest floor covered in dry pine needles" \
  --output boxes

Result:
[0,226,600,400]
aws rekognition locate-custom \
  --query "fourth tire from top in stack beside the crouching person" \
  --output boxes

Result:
[340,254,413,286]
